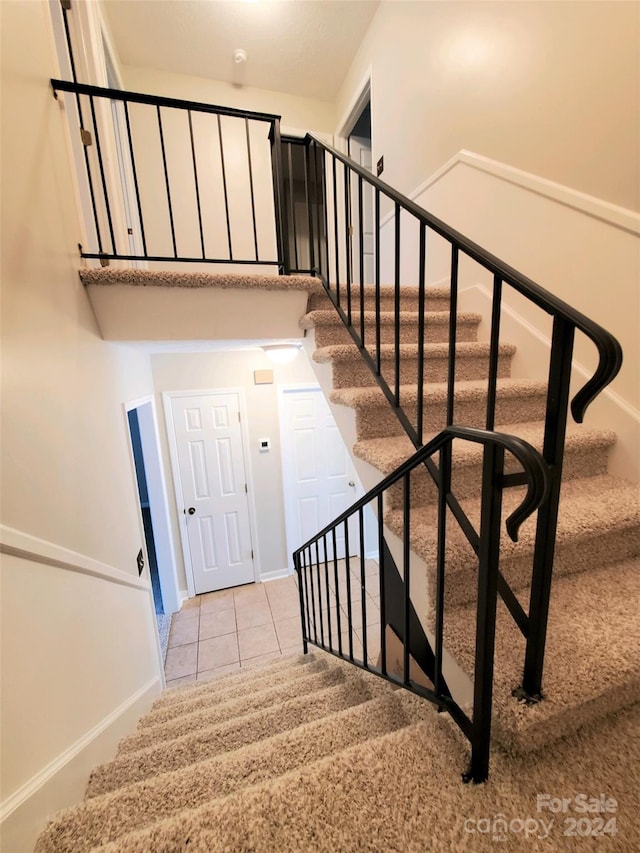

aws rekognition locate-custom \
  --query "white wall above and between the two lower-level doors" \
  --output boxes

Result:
[151,349,316,590]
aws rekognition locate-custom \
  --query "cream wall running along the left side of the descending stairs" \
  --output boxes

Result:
[1,2,161,851]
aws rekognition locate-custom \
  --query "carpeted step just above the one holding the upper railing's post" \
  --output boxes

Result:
[385,475,640,607]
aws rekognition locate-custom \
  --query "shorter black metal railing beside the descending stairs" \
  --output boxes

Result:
[293,426,550,782]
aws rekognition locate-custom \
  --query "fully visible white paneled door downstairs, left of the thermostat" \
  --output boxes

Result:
[171,393,255,593]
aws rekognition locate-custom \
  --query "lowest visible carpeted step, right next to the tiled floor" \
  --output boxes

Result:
[151,652,318,711]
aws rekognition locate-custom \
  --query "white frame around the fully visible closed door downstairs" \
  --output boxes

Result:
[162,387,260,598]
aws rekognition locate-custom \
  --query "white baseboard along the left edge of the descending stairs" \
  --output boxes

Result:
[0,678,162,853]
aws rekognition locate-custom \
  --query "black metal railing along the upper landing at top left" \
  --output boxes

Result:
[51,80,289,272]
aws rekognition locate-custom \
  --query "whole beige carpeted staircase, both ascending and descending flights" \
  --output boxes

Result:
[36,272,640,853]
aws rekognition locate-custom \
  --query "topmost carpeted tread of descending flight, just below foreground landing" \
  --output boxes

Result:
[36,691,416,853]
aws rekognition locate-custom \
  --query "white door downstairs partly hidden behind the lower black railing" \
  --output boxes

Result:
[281,388,359,565]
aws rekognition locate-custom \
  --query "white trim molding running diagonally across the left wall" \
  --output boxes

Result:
[0,524,150,591]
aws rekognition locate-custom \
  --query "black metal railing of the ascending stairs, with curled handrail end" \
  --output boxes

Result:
[298,135,622,701]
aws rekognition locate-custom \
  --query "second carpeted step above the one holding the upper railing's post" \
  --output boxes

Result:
[353,421,616,509]
